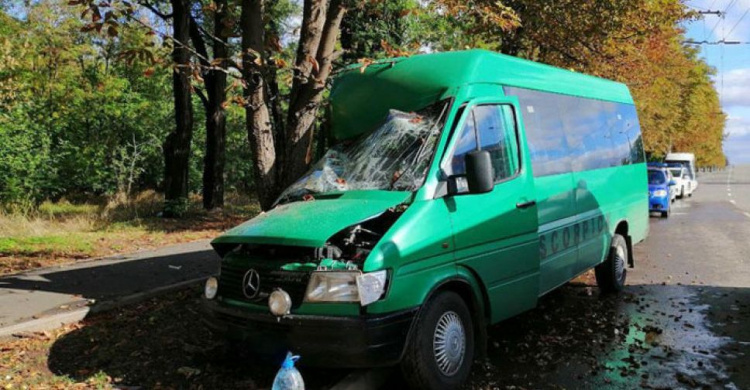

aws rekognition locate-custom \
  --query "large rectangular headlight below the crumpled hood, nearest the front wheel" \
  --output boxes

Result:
[305,270,388,306]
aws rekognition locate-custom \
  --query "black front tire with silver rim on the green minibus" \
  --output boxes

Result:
[401,291,474,389]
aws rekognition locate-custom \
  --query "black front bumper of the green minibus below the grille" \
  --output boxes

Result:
[203,299,418,368]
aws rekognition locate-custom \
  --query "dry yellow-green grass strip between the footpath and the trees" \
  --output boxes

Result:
[0,191,260,275]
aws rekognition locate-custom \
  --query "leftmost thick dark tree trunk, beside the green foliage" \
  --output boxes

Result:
[164,0,193,217]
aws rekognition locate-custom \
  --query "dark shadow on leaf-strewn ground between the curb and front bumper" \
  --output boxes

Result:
[47,286,346,389]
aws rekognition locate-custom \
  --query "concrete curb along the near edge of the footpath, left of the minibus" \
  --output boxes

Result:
[0,277,207,339]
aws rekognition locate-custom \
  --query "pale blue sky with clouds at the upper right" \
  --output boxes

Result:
[685,0,750,164]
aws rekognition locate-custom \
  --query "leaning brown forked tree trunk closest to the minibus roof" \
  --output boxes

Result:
[282,0,346,186]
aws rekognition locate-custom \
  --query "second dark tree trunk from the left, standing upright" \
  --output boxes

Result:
[200,0,229,210]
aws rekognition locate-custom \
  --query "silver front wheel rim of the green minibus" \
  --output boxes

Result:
[432,311,466,376]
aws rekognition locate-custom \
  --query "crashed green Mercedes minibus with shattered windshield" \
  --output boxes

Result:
[203,50,648,388]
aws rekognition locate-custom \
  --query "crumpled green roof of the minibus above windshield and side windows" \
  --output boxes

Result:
[330,50,633,140]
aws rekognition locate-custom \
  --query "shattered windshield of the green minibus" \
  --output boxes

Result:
[279,101,449,202]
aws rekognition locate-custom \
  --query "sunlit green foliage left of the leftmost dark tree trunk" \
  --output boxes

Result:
[0,1,170,203]
